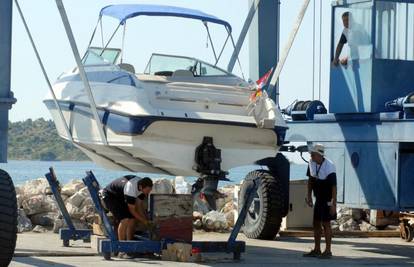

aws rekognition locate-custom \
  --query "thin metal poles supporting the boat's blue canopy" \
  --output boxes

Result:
[88,4,244,78]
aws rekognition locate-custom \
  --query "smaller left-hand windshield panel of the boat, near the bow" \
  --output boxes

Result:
[83,47,121,66]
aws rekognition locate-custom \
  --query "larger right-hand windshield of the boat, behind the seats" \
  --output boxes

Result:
[144,54,232,77]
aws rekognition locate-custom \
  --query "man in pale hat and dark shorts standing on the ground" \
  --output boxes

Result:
[303,144,337,259]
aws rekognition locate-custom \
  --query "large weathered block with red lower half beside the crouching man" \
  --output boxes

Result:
[150,194,193,243]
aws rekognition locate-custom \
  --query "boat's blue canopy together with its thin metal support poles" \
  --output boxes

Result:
[88,4,236,72]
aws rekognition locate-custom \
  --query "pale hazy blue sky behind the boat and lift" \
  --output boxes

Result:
[10,0,331,121]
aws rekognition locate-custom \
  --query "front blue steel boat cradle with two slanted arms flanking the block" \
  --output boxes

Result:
[83,171,258,260]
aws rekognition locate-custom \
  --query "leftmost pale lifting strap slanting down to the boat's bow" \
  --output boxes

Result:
[14,0,73,143]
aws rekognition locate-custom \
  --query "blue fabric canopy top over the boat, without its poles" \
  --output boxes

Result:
[99,4,232,32]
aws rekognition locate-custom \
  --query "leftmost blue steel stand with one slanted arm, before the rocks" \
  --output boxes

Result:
[45,168,92,247]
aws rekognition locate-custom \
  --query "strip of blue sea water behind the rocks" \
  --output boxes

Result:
[0,160,307,186]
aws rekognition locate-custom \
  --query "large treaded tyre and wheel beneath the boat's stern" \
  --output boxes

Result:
[238,170,289,240]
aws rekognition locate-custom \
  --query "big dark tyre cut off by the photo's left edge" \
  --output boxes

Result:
[0,170,17,266]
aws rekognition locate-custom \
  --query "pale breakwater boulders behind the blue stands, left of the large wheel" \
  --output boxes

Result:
[16,177,238,233]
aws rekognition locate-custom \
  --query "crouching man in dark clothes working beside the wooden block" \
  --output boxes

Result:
[103,175,153,245]
